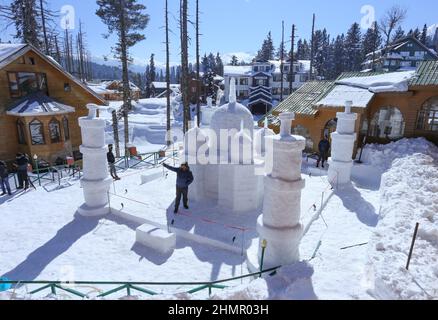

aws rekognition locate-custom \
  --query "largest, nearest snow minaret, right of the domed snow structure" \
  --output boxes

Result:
[257,113,306,269]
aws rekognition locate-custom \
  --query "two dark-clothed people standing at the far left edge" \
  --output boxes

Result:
[0,153,30,196]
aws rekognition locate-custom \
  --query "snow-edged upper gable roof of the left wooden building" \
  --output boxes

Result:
[0,43,107,105]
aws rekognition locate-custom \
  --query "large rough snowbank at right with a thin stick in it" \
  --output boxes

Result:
[369,139,438,299]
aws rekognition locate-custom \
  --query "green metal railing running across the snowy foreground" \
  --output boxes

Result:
[0,266,281,299]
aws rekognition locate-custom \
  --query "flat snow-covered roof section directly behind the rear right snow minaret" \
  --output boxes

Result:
[316,85,374,108]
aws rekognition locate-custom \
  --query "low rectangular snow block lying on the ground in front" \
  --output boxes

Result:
[136,224,176,254]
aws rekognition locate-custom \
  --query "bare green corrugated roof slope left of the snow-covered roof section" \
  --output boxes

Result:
[272,81,334,116]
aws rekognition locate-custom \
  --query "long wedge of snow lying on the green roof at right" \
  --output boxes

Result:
[336,71,415,93]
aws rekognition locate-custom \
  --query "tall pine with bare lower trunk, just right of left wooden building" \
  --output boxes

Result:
[96,0,149,155]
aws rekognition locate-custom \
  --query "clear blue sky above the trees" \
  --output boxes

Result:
[1,0,438,68]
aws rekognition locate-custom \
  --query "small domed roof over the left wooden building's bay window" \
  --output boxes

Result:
[6,93,75,117]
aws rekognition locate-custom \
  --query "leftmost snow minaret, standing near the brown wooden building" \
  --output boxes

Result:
[78,104,112,217]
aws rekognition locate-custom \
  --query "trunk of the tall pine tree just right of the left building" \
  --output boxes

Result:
[120,0,131,155]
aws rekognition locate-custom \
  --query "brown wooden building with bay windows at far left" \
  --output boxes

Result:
[0,44,106,163]
